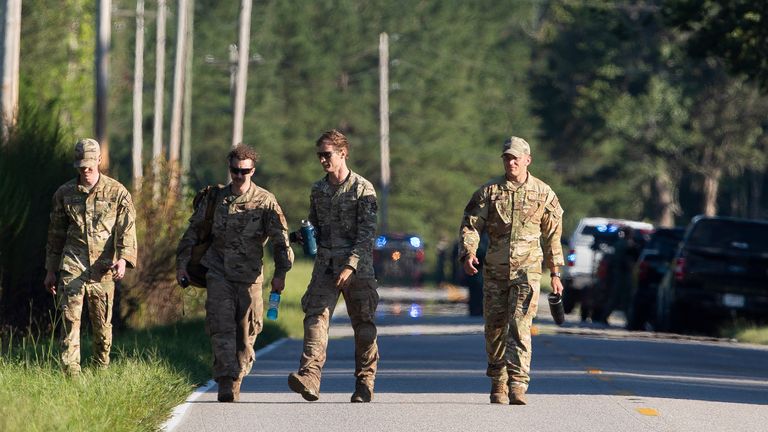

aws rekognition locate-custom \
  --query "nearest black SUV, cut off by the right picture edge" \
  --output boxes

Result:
[656,216,768,332]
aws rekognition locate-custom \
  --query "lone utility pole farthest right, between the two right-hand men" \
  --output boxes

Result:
[379,33,389,233]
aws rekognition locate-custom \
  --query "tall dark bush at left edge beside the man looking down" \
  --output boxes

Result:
[0,105,76,328]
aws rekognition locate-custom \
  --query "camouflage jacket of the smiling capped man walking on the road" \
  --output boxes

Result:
[459,173,563,279]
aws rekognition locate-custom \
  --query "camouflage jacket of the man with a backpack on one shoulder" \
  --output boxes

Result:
[176,183,293,283]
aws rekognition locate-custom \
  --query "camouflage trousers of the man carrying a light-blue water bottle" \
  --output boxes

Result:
[205,271,264,380]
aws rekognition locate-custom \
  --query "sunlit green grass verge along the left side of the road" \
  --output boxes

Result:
[0,260,312,431]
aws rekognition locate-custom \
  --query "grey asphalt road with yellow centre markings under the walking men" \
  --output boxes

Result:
[168,289,768,432]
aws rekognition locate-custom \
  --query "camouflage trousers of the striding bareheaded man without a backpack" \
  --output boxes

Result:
[299,268,379,388]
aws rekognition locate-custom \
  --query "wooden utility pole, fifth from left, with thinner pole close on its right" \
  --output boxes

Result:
[168,0,189,193]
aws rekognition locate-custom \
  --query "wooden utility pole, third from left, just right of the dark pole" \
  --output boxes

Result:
[131,0,144,192]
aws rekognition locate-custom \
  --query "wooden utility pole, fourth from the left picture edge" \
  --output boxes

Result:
[152,0,166,199]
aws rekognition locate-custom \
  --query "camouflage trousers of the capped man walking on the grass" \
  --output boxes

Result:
[59,272,115,375]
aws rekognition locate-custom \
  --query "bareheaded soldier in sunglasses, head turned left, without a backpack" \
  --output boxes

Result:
[288,130,379,402]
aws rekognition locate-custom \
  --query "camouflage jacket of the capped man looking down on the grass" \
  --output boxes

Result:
[45,174,136,282]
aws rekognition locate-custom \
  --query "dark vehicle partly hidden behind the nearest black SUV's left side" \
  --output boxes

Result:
[627,227,685,330]
